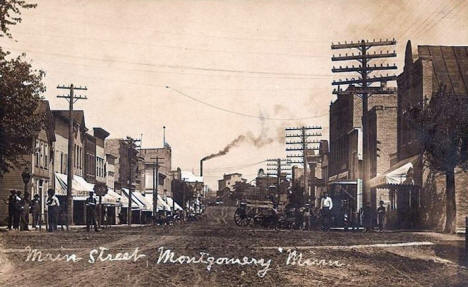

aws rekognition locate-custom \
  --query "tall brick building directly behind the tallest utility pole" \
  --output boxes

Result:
[327,83,397,214]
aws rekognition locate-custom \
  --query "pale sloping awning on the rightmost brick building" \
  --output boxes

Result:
[368,155,419,188]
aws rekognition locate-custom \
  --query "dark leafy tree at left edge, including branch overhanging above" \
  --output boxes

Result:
[0,0,45,177]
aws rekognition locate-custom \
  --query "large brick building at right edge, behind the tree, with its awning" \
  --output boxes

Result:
[370,41,468,230]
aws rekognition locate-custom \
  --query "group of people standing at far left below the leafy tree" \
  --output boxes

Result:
[8,189,41,230]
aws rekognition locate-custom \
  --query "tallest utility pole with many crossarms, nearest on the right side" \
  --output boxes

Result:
[331,39,397,205]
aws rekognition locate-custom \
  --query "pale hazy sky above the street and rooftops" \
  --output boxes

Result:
[0,0,468,189]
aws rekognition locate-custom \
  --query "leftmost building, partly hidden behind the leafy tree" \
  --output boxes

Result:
[0,101,55,224]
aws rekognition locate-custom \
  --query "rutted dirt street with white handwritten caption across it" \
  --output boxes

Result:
[0,207,468,287]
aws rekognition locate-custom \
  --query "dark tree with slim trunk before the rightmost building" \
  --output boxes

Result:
[416,86,468,232]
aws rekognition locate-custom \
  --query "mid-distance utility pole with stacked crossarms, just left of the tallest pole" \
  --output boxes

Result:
[286,126,322,206]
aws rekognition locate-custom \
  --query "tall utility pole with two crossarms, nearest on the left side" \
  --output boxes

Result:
[57,84,88,230]
